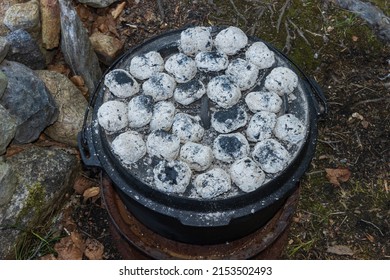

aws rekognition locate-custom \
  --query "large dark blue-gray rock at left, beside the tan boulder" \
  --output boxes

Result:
[0,60,58,143]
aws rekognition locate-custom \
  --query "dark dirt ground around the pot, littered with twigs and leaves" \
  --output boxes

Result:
[19,0,390,260]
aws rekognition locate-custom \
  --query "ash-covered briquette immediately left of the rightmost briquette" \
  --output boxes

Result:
[246,111,276,142]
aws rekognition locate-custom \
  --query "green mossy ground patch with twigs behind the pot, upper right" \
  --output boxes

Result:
[209,0,384,73]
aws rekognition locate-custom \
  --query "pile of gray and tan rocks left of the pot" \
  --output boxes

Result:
[0,0,123,259]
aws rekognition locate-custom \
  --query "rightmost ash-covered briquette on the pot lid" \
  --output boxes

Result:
[274,114,306,144]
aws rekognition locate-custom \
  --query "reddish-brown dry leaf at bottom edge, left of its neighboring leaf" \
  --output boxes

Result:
[54,232,84,260]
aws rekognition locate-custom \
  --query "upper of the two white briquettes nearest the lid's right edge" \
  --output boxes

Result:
[264,67,298,96]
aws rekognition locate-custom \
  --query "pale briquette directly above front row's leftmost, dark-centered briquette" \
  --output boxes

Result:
[146,130,180,160]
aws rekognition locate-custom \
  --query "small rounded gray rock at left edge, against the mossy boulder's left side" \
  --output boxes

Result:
[0,161,18,209]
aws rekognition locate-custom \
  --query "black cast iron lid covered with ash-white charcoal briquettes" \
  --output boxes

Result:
[80,27,326,229]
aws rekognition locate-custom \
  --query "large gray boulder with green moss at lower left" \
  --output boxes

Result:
[0,147,80,259]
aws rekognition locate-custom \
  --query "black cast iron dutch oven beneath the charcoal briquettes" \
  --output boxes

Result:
[78,27,326,244]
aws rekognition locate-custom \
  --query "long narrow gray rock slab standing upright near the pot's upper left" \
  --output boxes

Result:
[59,0,102,92]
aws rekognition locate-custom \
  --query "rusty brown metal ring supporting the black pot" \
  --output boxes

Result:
[102,175,299,259]
